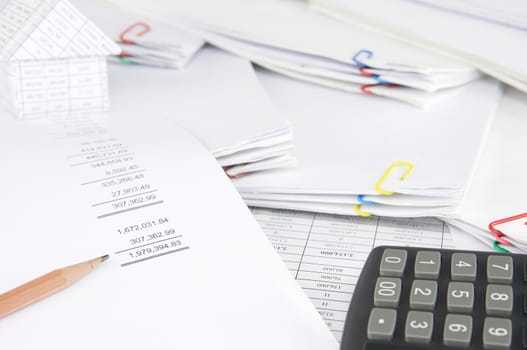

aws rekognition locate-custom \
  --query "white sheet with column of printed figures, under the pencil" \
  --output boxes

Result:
[0,112,337,350]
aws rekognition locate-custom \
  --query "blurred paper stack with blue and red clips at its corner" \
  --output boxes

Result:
[106,0,479,106]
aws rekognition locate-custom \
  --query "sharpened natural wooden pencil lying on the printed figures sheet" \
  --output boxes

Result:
[0,255,109,318]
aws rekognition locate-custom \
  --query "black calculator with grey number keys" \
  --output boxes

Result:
[341,247,527,350]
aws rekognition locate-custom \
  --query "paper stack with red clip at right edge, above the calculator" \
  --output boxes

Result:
[448,89,527,252]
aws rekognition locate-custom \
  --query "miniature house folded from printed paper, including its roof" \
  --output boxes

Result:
[0,0,120,118]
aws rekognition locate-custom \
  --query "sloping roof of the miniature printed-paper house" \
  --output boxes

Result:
[0,0,121,61]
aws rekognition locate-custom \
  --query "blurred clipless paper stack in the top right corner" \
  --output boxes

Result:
[310,0,527,92]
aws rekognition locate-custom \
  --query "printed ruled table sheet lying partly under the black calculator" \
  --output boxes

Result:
[252,208,455,341]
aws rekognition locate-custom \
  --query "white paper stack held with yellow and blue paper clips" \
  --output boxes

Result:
[235,66,501,217]
